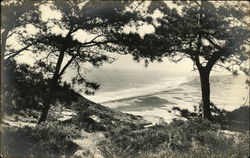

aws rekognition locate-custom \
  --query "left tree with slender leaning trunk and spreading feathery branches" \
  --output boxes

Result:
[5,0,139,124]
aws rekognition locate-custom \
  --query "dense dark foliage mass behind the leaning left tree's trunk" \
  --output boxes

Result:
[1,61,79,114]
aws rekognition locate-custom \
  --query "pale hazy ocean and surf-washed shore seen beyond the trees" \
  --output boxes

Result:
[83,69,249,123]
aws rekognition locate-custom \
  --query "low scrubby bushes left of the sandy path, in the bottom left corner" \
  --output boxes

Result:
[1,123,79,157]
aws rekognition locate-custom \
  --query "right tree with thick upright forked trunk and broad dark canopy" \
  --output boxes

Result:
[113,1,249,119]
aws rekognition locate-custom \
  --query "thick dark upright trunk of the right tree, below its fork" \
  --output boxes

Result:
[199,70,212,120]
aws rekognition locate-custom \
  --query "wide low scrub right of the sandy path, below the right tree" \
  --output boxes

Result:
[102,120,249,157]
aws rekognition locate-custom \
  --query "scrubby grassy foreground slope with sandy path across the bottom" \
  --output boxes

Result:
[1,101,250,158]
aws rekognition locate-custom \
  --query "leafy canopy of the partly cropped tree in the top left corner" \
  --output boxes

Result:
[1,0,43,58]
